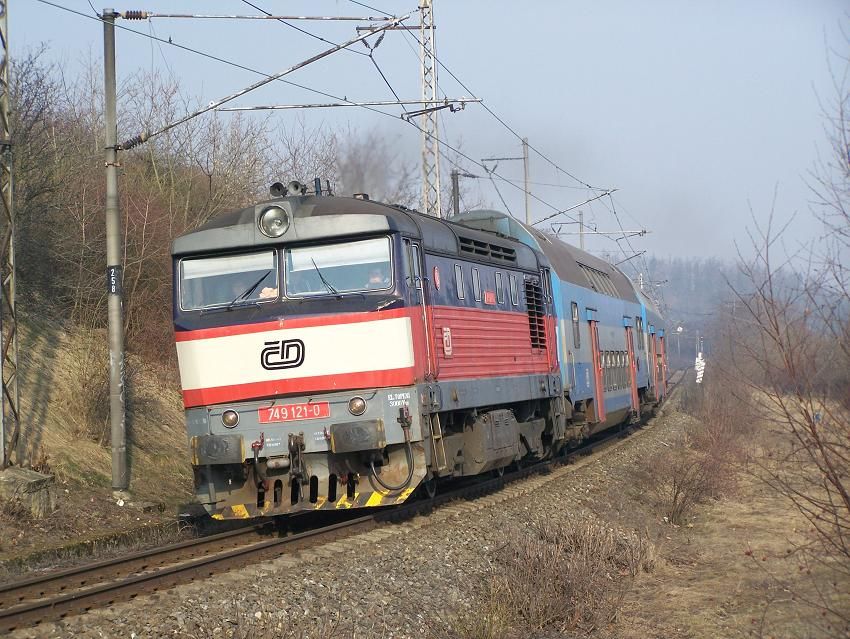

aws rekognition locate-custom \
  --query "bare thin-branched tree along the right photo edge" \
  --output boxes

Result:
[708,35,850,633]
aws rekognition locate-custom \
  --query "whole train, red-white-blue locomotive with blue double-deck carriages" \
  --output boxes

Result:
[172,183,666,519]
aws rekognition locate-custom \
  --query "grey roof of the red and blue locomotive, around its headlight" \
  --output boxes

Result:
[171,196,545,271]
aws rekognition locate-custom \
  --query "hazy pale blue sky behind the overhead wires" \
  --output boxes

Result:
[14,0,850,257]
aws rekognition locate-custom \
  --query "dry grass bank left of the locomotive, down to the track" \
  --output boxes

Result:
[0,318,192,561]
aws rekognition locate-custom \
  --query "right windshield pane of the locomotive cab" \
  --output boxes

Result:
[284,237,393,297]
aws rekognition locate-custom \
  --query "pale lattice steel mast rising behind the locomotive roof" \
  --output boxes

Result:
[419,0,442,217]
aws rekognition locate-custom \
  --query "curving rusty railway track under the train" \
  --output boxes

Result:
[0,371,684,633]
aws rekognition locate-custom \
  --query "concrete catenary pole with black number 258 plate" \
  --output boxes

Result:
[103,9,130,497]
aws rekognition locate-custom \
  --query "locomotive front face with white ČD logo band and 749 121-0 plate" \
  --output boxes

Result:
[172,197,426,518]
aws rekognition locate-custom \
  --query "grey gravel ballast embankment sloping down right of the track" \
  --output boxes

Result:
[11,397,687,638]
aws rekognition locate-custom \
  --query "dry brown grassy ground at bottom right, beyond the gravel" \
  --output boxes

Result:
[616,420,850,639]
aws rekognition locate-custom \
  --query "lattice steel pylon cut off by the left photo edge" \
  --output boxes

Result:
[0,0,21,468]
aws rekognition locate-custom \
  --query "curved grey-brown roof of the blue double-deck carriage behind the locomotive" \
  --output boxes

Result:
[452,209,638,302]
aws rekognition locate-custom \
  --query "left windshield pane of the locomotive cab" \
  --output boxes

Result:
[180,251,278,311]
